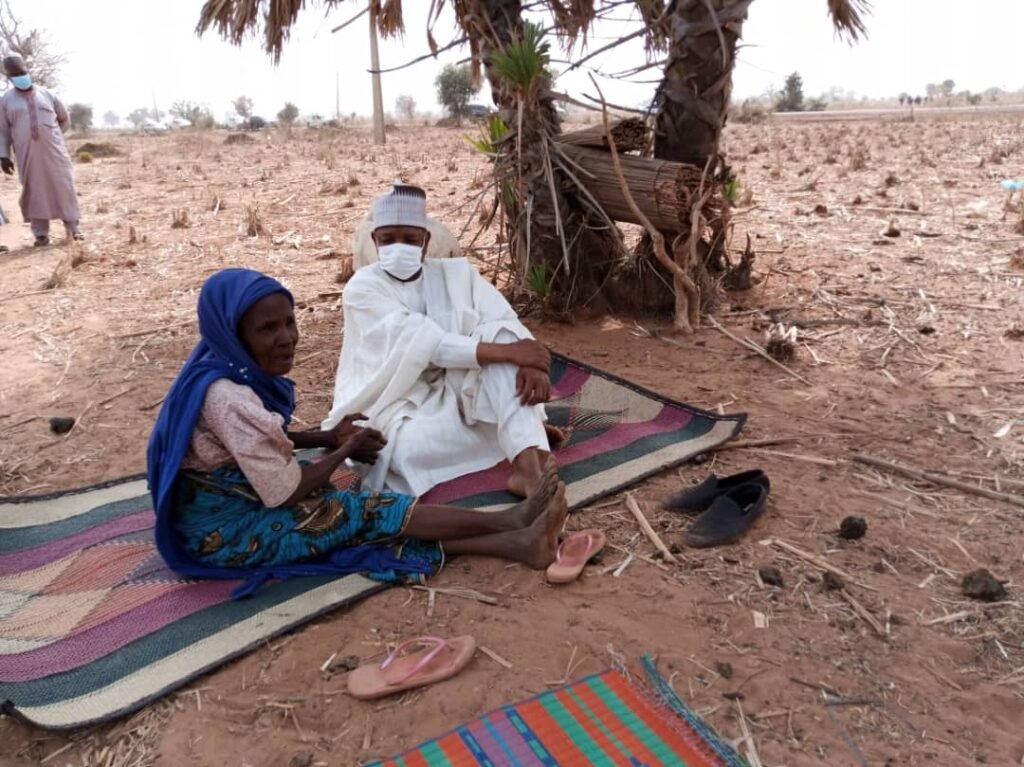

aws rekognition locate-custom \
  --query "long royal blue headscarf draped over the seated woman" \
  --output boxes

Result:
[145,269,426,597]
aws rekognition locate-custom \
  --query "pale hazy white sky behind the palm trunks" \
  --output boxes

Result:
[11,0,1024,124]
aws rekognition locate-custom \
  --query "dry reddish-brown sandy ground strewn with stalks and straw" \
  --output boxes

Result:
[0,119,1024,767]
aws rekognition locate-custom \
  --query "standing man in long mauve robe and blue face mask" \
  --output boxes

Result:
[0,54,85,246]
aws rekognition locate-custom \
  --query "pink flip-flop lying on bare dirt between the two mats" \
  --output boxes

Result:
[348,636,476,700]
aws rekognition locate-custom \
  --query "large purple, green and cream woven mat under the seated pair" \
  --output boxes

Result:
[0,357,743,728]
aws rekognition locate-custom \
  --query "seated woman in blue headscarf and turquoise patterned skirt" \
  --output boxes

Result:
[146,269,566,593]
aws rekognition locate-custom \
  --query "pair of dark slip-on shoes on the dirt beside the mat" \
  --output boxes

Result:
[662,469,771,549]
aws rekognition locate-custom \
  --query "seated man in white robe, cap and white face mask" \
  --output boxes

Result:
[324,184,551,496]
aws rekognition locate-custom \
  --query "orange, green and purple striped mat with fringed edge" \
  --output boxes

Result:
[368,658,746,767]
